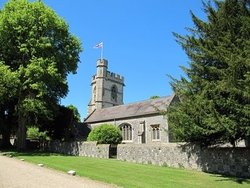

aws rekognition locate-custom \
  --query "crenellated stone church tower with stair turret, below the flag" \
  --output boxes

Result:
[88,59,124,114]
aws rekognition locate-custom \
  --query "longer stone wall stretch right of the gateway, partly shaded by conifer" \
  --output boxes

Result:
[117,143,250,178]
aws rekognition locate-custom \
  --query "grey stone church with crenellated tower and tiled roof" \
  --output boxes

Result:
[84,59,175,144]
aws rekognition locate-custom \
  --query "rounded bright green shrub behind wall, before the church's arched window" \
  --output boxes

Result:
[88,124,122,144]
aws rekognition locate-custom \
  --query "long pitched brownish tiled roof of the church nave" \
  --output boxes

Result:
[84,95,174,123]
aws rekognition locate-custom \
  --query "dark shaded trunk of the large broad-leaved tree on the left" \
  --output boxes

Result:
[17,112,26,151]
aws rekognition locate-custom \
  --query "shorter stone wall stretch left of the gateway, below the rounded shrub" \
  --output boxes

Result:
[47,141,110,159]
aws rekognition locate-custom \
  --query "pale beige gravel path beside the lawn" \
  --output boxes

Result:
[0,156,118,188]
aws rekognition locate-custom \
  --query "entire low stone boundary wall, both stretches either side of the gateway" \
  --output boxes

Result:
[48,142,250,178]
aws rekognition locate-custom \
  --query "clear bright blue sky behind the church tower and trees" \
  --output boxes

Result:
[0,0,205,119]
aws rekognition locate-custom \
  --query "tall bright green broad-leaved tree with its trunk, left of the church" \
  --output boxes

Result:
[0,0,81,149]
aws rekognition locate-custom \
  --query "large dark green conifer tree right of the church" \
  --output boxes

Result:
[168,0,250,145]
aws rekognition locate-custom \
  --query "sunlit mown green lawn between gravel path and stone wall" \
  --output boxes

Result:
[3,153,250,188]
